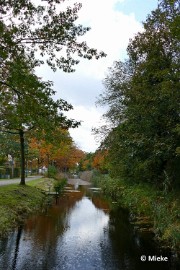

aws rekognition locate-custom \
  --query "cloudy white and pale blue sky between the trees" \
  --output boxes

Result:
[37,0,158,152]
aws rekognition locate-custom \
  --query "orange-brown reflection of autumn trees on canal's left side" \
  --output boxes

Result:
[3,189,84,270]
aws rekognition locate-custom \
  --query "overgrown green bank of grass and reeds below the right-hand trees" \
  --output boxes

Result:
[94,176,180,251]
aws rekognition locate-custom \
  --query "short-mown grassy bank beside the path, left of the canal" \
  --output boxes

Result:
[0,179,53,237]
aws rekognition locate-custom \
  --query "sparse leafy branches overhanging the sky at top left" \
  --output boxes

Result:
[0,0,105,78]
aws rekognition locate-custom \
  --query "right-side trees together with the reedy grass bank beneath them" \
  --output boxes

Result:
[89,0,180,253]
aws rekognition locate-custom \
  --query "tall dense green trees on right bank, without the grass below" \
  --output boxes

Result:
[96,0,180,188]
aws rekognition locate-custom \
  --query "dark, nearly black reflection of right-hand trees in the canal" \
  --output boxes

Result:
[102,209,170,270]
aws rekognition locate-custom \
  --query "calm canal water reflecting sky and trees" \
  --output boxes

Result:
[0,186,178,270]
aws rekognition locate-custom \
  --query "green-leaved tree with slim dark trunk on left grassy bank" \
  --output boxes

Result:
[0,58,80,184]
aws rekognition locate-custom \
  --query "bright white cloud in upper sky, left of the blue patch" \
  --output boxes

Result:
[67,0,142,79]
